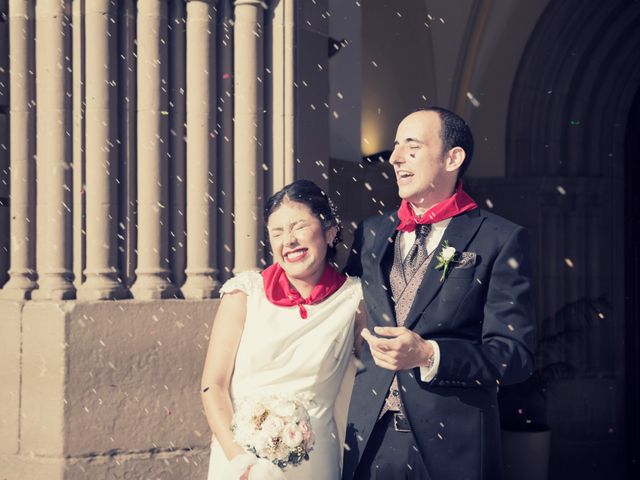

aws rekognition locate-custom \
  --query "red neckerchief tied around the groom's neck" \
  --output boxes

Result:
[396,181,478,232]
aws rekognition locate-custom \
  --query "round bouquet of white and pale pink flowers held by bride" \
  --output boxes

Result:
[231,395,315,469]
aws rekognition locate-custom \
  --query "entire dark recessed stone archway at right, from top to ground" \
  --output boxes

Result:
[506,0,640,479]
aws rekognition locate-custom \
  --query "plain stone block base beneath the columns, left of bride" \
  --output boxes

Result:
[0,300,218,480]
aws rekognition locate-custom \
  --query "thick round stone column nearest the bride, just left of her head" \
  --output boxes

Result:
[233,0,266,273]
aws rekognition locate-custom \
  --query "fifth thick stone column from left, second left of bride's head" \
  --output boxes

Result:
[182,0,220,298]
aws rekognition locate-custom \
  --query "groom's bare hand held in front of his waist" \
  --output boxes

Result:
[361,327,433,372]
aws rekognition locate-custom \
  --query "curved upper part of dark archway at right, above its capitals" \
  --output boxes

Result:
[507,0,640,177]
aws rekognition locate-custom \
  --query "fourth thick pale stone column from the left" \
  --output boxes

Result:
[131,0,175,299]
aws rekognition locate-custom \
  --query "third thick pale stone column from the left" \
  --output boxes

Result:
[78,0,127,300]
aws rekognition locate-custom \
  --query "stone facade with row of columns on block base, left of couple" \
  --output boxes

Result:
[0,0,328,480]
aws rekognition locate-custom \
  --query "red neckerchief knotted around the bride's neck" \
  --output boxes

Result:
[262,263,347,318]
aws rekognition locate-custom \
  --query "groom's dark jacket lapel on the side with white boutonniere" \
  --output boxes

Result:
[405,209,484,329]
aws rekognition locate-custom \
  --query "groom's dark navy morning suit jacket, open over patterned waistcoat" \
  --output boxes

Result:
[343,209,535,480]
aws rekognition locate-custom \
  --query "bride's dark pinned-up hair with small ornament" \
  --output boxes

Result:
[264,180,342,260]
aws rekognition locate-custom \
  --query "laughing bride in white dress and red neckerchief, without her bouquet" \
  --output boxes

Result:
[201,180,364,480]
